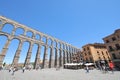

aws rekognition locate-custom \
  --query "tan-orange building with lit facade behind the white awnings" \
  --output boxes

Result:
[82,43,111,63]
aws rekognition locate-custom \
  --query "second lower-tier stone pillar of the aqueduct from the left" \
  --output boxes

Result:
[12,41,23,66]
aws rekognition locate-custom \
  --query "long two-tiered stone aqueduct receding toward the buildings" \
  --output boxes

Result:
[0,16,79,68]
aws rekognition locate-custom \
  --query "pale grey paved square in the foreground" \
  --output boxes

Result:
[0,69,120,80]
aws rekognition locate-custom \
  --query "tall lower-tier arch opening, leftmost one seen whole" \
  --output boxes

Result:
[3,39,19,64]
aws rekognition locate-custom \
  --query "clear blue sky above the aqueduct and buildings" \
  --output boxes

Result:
[0,0,120,63]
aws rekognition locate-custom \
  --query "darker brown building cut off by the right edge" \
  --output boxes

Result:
[103,29,120,62]
